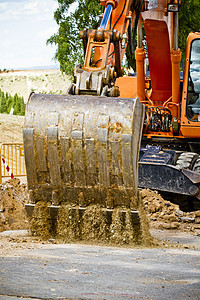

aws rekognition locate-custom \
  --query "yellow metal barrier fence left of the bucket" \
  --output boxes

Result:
[0,143,26,183]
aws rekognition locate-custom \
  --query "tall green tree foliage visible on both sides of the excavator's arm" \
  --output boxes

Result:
[47,0,200,74]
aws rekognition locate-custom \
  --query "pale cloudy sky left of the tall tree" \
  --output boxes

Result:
[0,0,59,70]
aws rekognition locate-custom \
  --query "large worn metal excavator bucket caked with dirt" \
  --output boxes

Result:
[23,93,144,244]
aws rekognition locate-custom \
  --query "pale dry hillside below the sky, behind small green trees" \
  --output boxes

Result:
[0,70,71,102]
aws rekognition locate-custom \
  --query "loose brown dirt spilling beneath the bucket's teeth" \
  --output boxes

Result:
[31,201,154,245]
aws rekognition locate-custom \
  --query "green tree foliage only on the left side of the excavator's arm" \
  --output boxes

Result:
[47,0,102,74]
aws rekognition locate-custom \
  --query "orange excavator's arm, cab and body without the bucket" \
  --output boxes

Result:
[71,0,200,210]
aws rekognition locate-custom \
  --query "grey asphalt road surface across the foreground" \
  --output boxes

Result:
[0,232,200,300]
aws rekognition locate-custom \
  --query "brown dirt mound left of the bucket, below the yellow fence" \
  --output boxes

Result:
[0,178,29,232]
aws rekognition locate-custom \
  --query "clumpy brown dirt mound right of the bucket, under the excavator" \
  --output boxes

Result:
[141,189,200,235]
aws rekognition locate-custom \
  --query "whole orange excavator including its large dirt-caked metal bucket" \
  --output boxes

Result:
[23,0,200,240]
